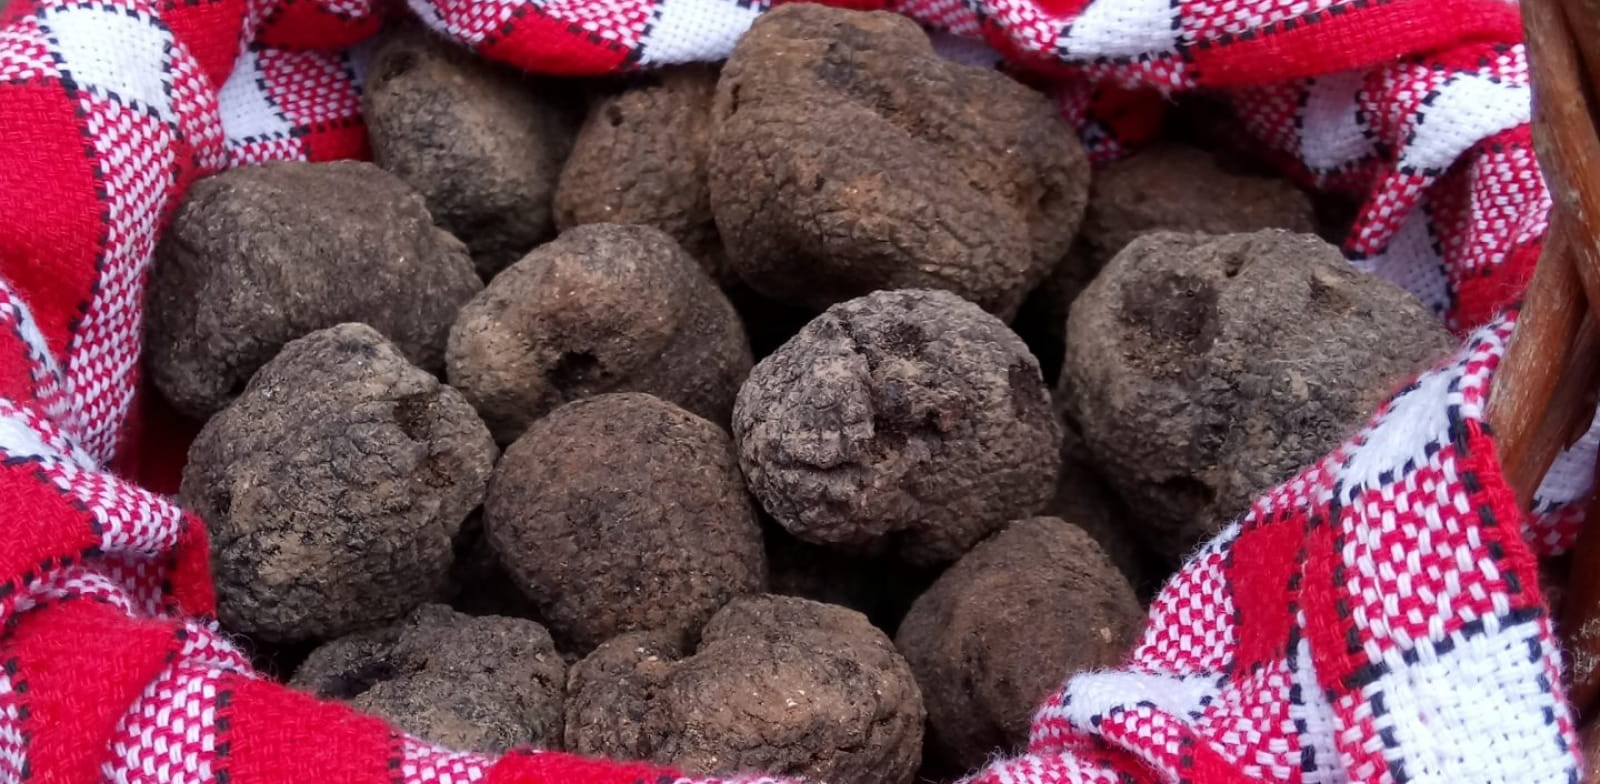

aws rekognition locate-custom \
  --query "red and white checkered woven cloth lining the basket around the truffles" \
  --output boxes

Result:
[0,0,1580,784]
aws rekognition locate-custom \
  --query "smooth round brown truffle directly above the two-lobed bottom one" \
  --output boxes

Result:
[483,394,766,651]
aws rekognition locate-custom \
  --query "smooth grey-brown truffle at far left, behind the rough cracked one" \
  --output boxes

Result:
[146,162,483,419]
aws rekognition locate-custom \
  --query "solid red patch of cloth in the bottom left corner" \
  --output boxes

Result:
[0,598,181,784]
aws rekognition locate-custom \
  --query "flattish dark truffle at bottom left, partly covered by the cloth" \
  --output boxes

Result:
[290,605,566,754]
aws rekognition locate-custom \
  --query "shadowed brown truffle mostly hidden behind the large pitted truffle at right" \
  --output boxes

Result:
[1018,144,1317,380]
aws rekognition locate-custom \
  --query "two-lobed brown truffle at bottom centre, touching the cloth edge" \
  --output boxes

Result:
[566,595,923,784]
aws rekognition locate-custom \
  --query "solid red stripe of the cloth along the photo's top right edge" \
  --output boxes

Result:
[1189,0,1522,88]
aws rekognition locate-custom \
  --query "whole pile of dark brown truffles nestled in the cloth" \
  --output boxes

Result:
[146,5,1450,784]
